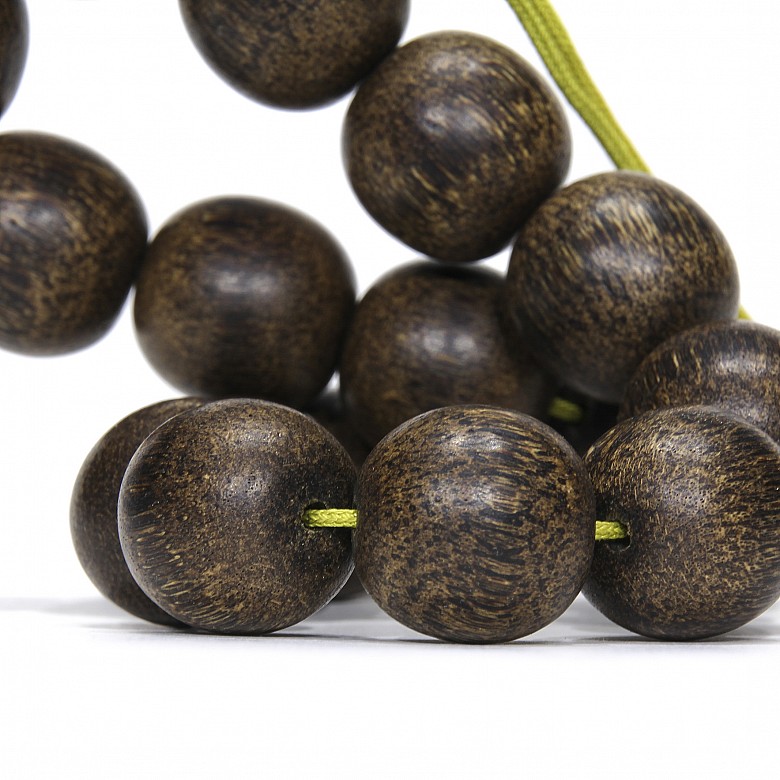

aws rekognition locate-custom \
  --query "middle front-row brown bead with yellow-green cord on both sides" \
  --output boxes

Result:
[355,406,595,642]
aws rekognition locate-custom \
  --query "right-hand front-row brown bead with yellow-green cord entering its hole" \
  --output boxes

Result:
[584,407,780,639]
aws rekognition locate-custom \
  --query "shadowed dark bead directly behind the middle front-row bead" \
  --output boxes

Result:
[339,262,553,445]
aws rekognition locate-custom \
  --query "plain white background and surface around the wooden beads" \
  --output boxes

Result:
[0,0,780,778]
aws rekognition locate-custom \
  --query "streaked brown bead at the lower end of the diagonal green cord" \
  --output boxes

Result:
[506,171,739,403]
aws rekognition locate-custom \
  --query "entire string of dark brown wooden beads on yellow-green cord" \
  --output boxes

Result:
[0,0,780,642]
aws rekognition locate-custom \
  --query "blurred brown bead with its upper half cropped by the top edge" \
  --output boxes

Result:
[179,0,409,108]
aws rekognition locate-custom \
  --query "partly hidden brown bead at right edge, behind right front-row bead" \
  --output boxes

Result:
[620,321,780,441]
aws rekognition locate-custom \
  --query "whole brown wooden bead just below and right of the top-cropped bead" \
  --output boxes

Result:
[343,32,571,261]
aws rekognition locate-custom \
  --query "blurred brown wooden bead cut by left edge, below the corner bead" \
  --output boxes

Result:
[0,133,147,355]
